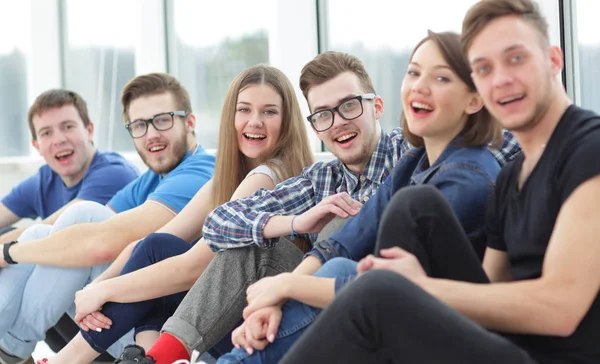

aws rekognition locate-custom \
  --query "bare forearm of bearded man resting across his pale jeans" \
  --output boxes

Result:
[10,223,120,267]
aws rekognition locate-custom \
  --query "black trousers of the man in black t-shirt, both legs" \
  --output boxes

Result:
[281,186,536,364]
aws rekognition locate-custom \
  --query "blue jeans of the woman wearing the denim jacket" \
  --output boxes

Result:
[217,258,356,364]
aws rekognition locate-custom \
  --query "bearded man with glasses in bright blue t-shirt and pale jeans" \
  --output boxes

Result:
[0,74,215,363]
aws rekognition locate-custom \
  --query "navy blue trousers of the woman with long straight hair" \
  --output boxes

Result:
[81,233,193,353]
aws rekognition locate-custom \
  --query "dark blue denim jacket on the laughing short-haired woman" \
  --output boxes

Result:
[307,137,500,263]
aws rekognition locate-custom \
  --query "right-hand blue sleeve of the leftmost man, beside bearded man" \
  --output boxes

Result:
[75,164,138,205]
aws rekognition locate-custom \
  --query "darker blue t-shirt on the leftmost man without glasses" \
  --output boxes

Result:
[2,150,139,219]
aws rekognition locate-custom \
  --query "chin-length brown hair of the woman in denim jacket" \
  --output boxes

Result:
[400,30,502,147]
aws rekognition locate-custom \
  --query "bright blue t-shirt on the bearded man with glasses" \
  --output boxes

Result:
[108,146,215,213]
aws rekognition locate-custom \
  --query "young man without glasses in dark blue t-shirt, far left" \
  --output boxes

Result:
[0,90,138,242]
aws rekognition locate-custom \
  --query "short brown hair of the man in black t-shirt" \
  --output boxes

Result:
[461,0,550,53]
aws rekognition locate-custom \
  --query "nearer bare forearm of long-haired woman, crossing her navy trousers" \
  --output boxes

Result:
[99,240,214,303]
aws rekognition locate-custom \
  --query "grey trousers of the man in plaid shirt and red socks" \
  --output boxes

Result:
[163,219,345,353]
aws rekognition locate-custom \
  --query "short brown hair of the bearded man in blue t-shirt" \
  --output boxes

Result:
[121,73,192,121]
